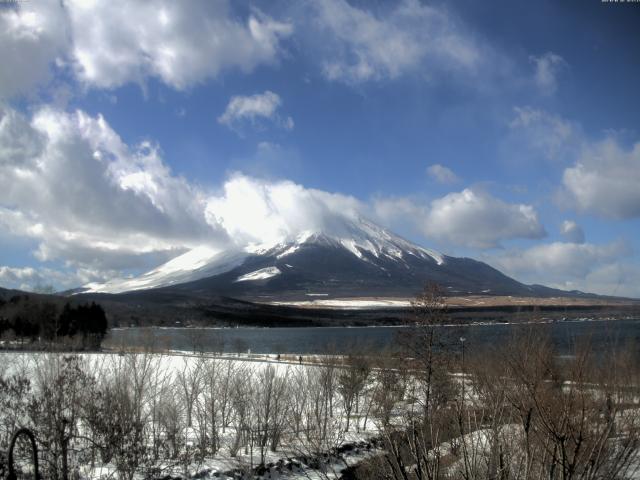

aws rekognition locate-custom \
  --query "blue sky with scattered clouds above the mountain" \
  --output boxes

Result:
[0,0,640,296]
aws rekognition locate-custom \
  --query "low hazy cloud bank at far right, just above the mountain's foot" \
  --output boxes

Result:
[484,242,640,297]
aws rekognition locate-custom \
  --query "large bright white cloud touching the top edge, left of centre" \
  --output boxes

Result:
[65,0,292,89]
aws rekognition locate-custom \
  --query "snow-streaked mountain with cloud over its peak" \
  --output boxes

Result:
[81,217,580,301]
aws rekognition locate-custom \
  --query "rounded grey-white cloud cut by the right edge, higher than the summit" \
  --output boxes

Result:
[562,136,640,219]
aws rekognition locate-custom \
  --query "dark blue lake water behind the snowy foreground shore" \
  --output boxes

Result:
[105,319,640,354]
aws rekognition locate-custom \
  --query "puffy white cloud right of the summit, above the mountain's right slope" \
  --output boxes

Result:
[374,188,546,249]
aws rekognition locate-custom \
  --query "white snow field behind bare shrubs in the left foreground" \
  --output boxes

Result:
[0,353,378,479]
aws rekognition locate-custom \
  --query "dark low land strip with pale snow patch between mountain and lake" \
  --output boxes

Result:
[0,289,640,327]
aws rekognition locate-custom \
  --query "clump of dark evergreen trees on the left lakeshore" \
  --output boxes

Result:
[0,295,108,350]
